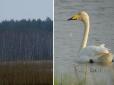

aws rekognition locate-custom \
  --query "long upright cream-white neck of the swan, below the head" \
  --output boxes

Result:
[81,19,90,48]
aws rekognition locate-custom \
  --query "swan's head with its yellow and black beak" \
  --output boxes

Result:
[68,11,89,22]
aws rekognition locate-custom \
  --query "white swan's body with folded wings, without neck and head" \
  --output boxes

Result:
[79,44,112,63]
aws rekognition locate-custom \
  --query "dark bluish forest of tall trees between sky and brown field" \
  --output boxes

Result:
[0,17,53,61]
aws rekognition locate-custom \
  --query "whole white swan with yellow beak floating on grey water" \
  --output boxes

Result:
[68,11,113,63]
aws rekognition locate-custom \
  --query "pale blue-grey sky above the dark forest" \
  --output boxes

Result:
[0,0,53,21]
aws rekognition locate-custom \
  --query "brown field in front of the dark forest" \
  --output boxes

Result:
[0,60,53,85]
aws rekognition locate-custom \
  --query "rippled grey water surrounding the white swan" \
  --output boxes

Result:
[54,0,114,85]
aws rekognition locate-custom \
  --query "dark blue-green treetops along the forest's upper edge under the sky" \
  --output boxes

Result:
[0,17,53,31]
